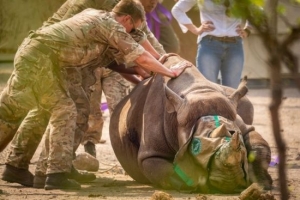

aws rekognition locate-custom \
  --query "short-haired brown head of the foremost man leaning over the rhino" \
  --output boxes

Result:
[112,0,146,32]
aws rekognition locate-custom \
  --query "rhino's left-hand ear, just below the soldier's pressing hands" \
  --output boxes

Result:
[165,84,183,113]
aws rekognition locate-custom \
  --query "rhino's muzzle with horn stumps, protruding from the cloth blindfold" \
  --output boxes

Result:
[208,124,249,193]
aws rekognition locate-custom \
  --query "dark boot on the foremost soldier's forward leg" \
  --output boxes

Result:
[45,173,81,190]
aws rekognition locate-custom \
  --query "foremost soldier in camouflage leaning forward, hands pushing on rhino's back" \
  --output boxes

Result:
[0,0,183,189]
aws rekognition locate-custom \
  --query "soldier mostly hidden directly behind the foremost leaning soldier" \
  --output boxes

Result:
[0,0,102,187]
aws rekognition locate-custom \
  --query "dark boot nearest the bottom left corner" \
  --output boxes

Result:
[1,164,33,187]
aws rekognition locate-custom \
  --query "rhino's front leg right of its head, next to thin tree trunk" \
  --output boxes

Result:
[243,131,273,190]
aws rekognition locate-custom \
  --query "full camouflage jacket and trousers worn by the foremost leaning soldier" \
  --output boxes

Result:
[0,9,144,174]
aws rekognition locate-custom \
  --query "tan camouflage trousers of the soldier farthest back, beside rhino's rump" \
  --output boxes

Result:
[82,68,131,145]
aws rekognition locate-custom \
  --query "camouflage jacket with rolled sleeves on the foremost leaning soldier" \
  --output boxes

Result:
[33,8,144,67]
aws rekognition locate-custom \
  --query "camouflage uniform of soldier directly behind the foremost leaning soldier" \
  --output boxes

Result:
[0,0,95,169]
